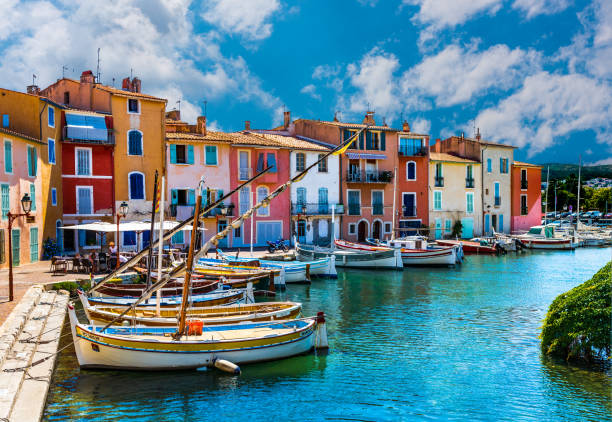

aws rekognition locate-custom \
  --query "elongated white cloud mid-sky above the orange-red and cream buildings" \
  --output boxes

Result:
[401,45,539,107]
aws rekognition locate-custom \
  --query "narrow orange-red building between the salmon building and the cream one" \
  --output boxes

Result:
[395,122,429,236]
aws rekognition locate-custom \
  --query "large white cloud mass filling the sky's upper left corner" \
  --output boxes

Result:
[0,0,281,124]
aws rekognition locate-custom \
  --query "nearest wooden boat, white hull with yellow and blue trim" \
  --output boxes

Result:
[68,304,327,371]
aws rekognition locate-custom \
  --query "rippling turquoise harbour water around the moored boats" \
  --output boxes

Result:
[44,249,612,421]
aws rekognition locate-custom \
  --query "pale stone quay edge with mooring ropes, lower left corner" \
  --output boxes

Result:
[0,285,69,422]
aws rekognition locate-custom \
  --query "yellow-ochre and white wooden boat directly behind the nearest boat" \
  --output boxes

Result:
[79,291,302,327]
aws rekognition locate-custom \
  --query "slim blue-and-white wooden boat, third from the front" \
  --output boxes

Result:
[81,287,249,308]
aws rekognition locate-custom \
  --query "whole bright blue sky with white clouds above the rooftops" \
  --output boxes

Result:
[0,0,612,163]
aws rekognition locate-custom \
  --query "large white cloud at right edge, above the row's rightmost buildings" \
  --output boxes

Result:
[476,72,612,155]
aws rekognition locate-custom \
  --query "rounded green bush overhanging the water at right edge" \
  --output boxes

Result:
[540,262,612,360]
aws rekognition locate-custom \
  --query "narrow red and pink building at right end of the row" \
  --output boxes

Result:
[511,161,542,233]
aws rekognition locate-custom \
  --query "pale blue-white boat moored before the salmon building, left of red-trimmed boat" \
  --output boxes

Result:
[295,243,403,269]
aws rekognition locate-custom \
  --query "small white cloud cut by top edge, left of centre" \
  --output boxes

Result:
[202,0,281,40]
